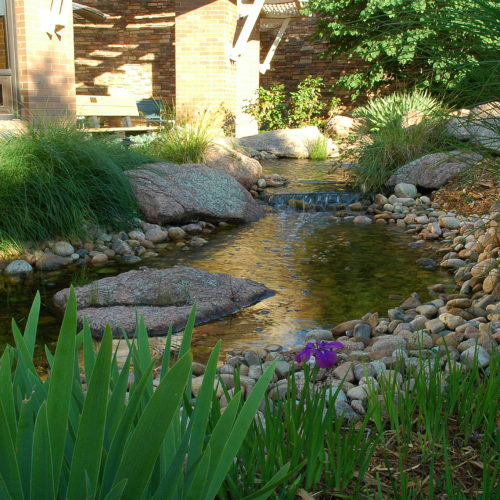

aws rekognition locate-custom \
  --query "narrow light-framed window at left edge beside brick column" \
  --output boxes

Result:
[0,0,15,118]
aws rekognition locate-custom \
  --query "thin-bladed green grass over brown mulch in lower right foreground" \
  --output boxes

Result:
[220,353,500,500]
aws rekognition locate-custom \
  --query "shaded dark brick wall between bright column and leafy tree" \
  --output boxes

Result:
[260,18,362,104]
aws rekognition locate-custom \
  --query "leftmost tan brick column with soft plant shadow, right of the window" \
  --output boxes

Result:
[16,0,75,119]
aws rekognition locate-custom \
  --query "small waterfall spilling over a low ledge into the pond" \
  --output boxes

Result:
[267,191,362,210]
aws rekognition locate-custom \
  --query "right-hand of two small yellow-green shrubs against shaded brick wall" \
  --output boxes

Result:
[289,75,326,127]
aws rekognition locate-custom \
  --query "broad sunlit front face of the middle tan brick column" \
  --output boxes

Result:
[175,0,237,115]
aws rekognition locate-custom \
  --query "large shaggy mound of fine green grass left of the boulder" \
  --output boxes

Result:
[0,123,145,250]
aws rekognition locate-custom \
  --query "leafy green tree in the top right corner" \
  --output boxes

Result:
[307,0,500,102]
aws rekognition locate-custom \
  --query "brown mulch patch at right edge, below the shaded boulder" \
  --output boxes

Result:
[432,158,500,215]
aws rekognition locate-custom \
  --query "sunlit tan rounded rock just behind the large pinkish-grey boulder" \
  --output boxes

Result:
[203,139,262,189]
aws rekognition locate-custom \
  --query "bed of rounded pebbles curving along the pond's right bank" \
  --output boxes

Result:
[192,184,500,420]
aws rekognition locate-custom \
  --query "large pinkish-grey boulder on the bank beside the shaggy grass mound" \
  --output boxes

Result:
[126,163,264,224]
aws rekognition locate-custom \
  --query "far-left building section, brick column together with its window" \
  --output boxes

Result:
[0,0,75,128]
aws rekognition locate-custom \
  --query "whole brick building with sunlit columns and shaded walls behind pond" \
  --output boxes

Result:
[0,0,352,135]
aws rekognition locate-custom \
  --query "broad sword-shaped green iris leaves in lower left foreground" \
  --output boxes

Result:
[0,290,282,500]
